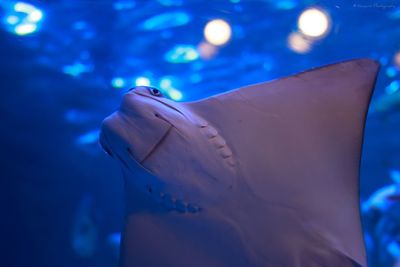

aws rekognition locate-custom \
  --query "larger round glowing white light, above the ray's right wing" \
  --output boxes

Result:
[298,8,330,38]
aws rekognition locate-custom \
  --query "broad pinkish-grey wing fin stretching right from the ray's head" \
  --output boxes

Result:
[186,59,379,265]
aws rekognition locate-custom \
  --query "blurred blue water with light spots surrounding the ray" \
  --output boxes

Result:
[0,0,400,267]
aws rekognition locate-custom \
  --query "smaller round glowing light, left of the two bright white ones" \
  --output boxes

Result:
[204,19,232,45]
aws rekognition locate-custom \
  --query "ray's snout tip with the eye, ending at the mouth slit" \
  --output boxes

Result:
[102,86,184,163]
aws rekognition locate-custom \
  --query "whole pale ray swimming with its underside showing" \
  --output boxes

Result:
[100,59,379,267]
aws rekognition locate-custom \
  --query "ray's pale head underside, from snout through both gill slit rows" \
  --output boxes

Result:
[100,86,236,213]
